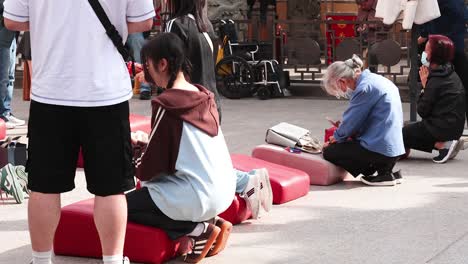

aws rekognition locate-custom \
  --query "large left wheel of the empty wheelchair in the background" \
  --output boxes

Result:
[215,56,253,99]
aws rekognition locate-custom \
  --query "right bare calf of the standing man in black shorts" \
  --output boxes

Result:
[94,194,127,256]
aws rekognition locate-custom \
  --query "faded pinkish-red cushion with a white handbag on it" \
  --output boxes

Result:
[252,145,347,185]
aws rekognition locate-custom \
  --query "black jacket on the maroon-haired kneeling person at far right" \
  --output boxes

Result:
[418,64,465,141]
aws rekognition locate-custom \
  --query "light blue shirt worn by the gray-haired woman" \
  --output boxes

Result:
[334,70,405,157]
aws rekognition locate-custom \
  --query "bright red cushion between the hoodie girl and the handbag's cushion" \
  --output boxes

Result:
[231,155,310,204]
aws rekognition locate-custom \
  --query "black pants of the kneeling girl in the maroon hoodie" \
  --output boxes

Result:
[126,187,198,240]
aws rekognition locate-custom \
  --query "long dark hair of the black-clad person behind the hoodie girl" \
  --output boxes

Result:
[169,0,208,32]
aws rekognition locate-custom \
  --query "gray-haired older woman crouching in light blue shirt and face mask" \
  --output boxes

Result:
[322,55,405,186]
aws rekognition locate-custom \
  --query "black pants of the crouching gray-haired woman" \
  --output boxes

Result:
[323,141,397,177]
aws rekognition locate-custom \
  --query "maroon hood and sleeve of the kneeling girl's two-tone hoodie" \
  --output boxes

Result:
[136,85,219,181]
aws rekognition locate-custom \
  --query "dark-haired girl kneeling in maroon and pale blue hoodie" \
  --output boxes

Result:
[127,33,236,262]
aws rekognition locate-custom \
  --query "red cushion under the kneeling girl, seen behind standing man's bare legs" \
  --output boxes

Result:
[54,199,179,263]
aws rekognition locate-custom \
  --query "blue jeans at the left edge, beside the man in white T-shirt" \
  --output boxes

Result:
[0,28,16,116]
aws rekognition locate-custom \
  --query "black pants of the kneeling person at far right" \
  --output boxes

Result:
[403,122,438,153]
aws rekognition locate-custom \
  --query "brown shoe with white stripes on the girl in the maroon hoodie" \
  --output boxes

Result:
[184,223,221,263]
